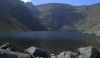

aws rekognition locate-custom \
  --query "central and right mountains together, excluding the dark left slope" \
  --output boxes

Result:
[27,3,100,33]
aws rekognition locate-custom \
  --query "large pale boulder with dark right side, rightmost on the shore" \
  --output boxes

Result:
[78,46,100,58]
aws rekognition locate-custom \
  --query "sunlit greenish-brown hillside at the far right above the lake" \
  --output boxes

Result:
[76,3,100,35]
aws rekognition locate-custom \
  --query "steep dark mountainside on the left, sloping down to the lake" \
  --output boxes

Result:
[0,0,46,32]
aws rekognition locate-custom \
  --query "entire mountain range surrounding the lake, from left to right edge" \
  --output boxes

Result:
[0,0,100,34]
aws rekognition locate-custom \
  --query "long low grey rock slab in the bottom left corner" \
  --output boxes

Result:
[0,49,31,58]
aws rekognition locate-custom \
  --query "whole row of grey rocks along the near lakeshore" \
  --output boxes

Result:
[0,44,100,58]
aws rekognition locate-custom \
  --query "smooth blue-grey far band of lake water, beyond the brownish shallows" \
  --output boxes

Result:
[0,31,90,39]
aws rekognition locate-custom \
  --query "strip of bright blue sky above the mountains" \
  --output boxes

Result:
[23,0,100,6]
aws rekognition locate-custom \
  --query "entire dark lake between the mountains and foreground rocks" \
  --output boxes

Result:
[0,31,99,53]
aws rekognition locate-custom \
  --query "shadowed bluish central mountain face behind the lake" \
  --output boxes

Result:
[36,3,85,31]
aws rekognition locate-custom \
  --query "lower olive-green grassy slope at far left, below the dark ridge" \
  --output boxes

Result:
[0,12,31,32]
